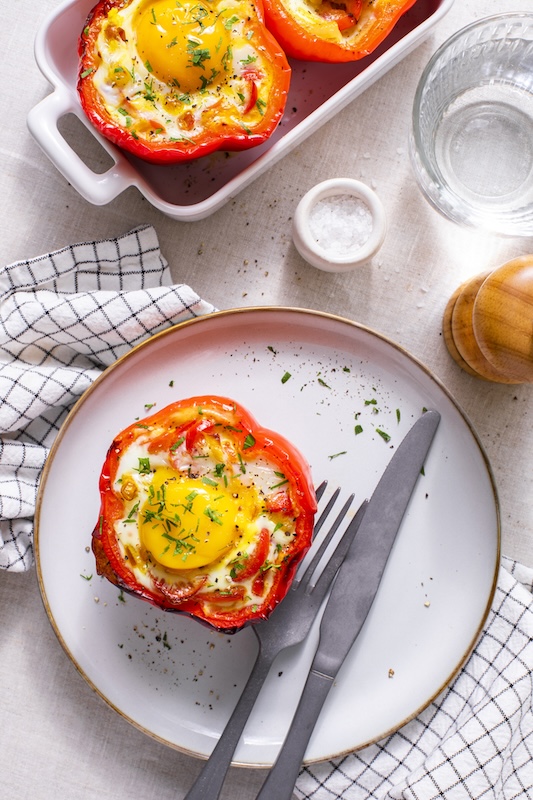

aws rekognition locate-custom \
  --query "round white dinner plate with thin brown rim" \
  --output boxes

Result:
[36,308,500,767]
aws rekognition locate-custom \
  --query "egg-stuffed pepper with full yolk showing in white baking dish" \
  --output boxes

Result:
[78,0,290,164]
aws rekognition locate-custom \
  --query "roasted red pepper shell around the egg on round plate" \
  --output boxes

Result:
[92,396,316,633]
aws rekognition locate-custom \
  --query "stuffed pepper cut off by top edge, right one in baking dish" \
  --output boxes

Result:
[264,0,416,63]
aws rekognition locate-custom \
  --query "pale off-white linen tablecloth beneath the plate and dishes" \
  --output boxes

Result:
[0,0,533,800]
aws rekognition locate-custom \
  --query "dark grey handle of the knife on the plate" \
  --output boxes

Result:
[256,671,333,800]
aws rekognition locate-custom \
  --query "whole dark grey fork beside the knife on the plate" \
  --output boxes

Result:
[184,482,366,800]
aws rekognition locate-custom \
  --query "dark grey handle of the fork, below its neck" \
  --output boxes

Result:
[184,650,274,800]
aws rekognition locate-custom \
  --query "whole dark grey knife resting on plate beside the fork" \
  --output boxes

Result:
[256,411,440,800]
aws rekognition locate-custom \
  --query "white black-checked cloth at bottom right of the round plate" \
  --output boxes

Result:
[296,558,533,800]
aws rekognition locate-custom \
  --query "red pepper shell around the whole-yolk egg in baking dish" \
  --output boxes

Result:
[77,0,291,164]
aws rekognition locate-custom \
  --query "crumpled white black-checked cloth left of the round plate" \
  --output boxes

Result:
[0,226,216,572]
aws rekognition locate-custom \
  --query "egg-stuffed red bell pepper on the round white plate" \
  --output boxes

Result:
[93,397,316,632]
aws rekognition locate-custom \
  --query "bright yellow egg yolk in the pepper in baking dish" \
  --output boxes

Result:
[135,0,231,92]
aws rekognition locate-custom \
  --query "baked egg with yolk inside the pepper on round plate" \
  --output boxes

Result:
[113,432,295,605]
